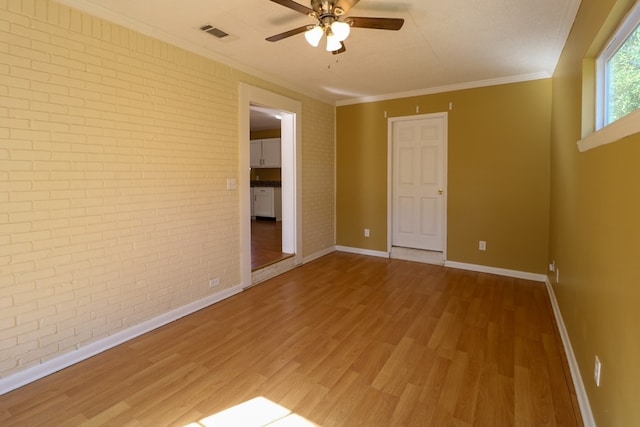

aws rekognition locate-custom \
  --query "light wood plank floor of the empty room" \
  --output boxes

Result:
[0,252,582,426]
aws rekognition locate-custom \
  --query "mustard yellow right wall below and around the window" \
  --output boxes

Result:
[549,0,640,426]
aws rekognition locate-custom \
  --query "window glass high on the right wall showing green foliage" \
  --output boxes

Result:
[596,3,640,129]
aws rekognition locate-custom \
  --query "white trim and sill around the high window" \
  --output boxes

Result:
[578,1,640,152]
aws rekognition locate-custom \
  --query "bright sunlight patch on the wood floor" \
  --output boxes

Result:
[185,396,316,427]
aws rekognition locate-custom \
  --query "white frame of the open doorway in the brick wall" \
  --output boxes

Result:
[239,83,302,288]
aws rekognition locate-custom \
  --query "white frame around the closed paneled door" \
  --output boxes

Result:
[387,112,449,260]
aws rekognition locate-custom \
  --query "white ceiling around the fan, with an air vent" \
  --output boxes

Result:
[59,0,580,105]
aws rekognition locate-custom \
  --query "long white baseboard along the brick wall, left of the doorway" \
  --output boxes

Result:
[0,285,242,396]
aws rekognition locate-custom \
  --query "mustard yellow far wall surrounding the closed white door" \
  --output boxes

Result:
[336,79,551,273]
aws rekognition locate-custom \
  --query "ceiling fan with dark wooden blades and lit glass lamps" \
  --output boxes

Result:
[266,0,404,55]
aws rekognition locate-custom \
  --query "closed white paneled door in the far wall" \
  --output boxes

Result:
[391,114,447,251]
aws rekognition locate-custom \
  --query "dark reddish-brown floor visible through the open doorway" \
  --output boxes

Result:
[251,219,293,271]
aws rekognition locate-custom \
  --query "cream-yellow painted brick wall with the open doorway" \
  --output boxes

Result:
[0,0,335,379]
